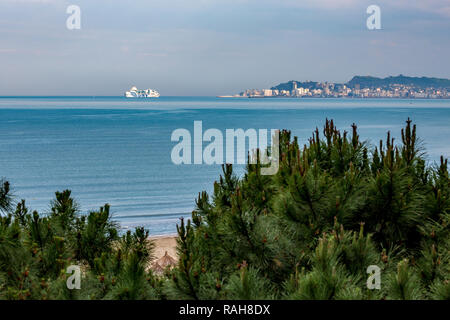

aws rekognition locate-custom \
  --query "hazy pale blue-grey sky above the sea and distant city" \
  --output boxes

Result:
[0,0,450,96]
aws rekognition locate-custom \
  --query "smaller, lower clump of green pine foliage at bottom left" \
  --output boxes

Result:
[0,190,158,300]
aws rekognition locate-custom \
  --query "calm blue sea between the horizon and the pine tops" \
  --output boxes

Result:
[0,97,450,235]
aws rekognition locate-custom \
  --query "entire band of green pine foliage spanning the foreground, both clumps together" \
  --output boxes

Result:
[0,119,450,300]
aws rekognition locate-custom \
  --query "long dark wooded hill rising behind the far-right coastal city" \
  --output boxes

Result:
[346,75,450,89]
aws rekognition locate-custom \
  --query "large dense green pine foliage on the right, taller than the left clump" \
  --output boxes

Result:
[166,119,450,299]
